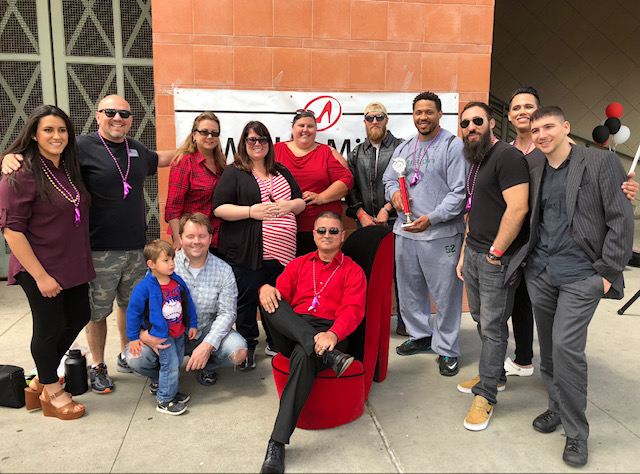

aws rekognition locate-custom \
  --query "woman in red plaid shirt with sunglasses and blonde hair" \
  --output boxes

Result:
[164,112,227,250]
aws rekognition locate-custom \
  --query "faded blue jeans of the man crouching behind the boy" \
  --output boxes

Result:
[125,328,247,384]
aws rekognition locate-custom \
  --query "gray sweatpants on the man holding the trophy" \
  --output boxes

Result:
[395,234,463,357]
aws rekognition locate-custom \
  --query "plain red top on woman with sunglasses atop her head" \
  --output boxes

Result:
[275,142,353,232]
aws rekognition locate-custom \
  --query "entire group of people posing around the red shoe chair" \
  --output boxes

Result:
[0,87,638,472]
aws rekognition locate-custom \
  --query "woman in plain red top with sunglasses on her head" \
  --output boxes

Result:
[275,109,353,255]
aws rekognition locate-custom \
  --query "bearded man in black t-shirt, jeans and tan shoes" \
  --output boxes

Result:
[457,102,529,431]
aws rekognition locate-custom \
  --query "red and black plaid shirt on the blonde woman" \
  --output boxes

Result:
[164,151,222,248]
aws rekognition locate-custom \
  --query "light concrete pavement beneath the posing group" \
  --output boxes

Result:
[0,267,640,472]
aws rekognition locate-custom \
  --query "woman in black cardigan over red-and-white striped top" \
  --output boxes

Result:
[213,121,306,370]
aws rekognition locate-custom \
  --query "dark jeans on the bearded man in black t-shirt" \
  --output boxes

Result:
[462,246,516,405]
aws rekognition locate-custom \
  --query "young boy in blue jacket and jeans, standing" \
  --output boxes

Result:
[127,239,198,415]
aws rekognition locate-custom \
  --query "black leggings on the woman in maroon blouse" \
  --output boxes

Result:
[16,272,91,384]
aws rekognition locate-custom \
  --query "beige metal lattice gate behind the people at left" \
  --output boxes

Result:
[0,0,160,276]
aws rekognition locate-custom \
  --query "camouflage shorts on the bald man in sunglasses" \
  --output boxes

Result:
[89,249,147,322]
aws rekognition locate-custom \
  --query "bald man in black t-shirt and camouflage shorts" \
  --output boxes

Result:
[2,95,174,393]
